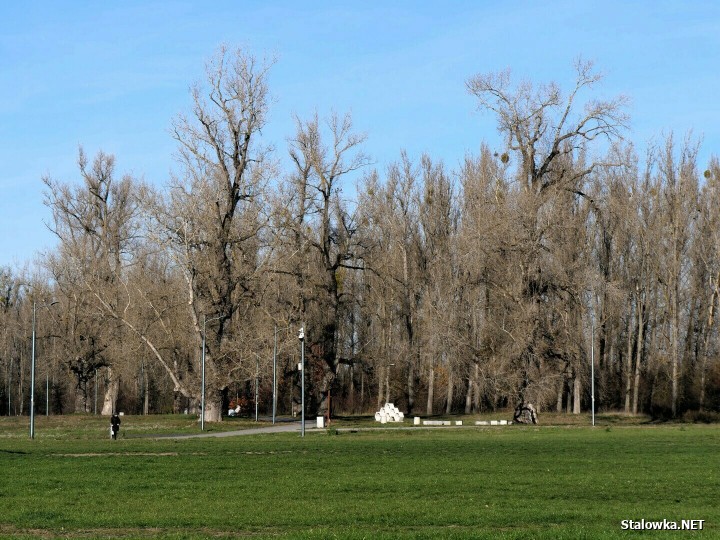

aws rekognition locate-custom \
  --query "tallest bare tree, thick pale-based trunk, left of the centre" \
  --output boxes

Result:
[159,47,272,421]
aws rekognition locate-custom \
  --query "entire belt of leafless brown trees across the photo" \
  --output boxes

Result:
[0,48,720,421]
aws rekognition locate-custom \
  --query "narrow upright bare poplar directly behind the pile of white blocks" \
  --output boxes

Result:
[362,153,428,414]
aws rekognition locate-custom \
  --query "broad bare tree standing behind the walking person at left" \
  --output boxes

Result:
[43,148,138,415]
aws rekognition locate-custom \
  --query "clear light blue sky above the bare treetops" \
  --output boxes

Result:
[0,0,720,270]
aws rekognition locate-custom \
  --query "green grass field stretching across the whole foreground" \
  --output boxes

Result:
[0,416,720,539]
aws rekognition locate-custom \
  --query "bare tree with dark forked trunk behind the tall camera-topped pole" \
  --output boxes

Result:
[284,109,369,411]
